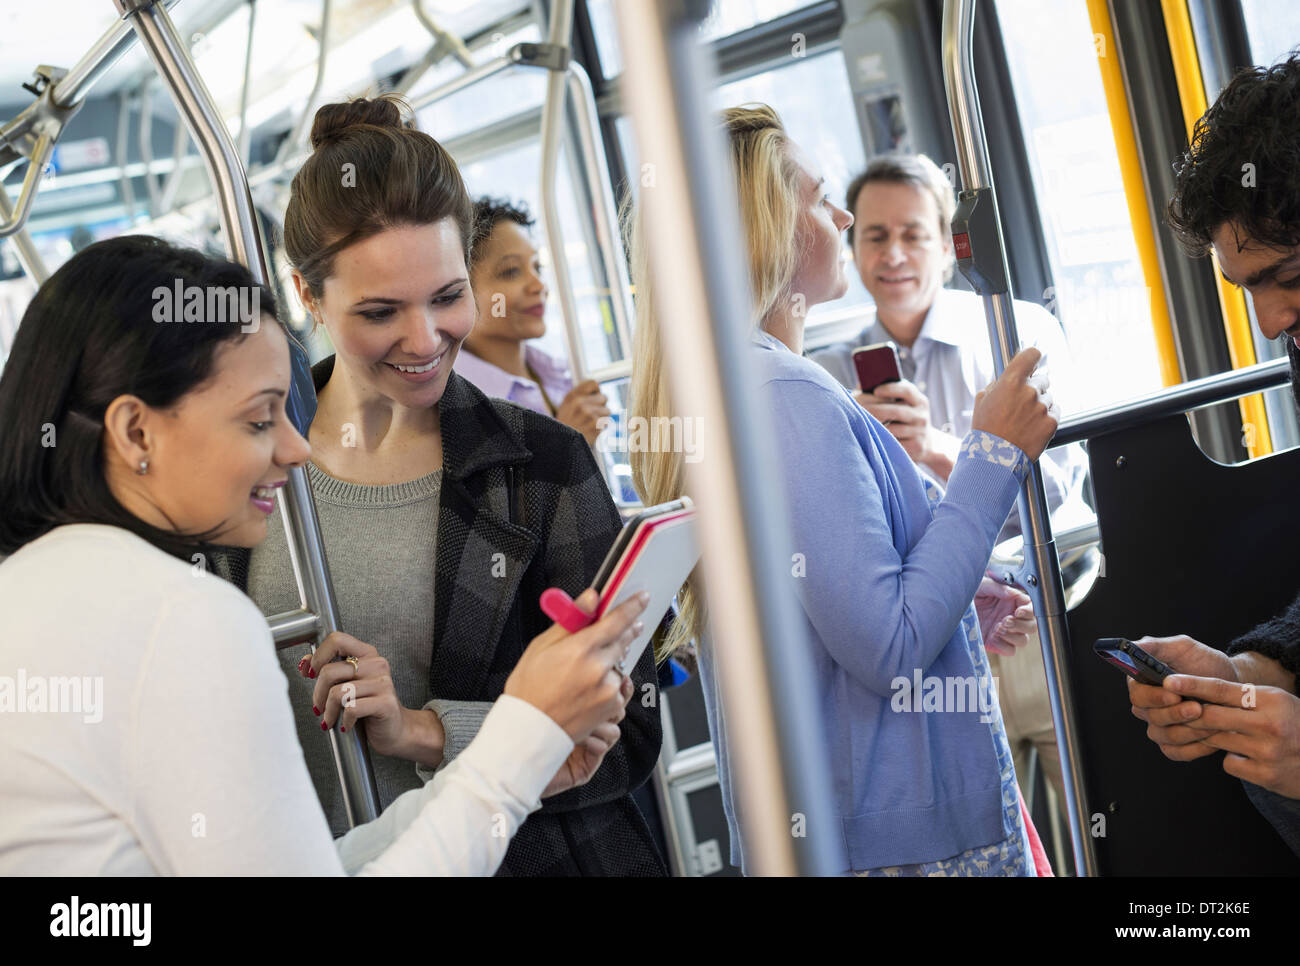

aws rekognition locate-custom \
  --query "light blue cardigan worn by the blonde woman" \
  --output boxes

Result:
[701,332,1028,870]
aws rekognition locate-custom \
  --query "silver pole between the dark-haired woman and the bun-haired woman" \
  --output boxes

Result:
[114,0,380,826]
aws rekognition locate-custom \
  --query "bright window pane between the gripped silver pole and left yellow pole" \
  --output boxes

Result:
[997,0,1161,408]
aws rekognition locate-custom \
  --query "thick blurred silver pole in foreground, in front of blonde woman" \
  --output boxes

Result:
[616,0,848,875]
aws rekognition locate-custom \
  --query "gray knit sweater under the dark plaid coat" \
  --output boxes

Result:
[248,463,491,836]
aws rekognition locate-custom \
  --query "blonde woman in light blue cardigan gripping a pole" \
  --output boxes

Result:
[631,105,1056,875]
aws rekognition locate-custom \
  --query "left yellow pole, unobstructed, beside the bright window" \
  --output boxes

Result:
[1088,0,1183,386]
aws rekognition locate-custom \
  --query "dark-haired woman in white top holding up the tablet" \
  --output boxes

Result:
[0,237,644,875]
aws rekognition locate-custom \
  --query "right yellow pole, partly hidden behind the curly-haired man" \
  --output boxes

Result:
[1161,0,1273,458]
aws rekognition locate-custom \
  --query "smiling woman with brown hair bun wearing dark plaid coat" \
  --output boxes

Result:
[218,95,664,875]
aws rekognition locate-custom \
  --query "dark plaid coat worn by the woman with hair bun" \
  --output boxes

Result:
[220,356,667,875]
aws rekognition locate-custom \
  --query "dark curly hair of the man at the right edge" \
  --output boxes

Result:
[1166,48,1300,256]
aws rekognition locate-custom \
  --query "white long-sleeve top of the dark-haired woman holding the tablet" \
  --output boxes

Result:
[0,524,573,875]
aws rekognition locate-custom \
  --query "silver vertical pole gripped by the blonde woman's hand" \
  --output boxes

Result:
[943,0,1097,875]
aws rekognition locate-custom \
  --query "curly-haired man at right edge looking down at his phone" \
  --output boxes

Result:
[1128,56,1300,854]
